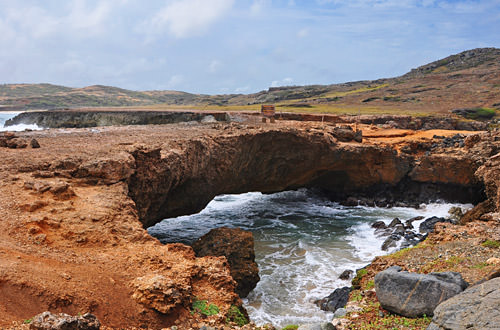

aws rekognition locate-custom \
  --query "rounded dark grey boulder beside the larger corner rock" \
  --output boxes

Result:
[375,266,468,317]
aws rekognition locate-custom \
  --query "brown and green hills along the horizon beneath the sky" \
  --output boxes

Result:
[0,48,500,114]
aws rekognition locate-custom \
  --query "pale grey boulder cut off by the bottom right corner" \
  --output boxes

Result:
[427,278,500,330]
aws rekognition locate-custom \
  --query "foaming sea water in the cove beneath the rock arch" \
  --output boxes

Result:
[148,189,468,327]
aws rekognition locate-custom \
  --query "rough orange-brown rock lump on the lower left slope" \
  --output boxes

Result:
[132,274,191,314]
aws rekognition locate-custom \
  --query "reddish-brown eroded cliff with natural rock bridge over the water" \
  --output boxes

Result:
[0,122,500,328]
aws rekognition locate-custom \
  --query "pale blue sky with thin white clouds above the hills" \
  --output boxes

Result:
[0,0,500,94]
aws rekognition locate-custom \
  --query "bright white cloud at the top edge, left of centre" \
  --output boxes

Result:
[146,0,234,38]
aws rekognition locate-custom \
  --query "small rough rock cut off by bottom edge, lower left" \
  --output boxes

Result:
[30,312,101,330]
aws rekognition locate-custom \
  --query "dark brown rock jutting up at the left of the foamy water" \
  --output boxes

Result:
[193,227,260,298]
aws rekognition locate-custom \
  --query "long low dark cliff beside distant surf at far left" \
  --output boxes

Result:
[5,110,229,128]
